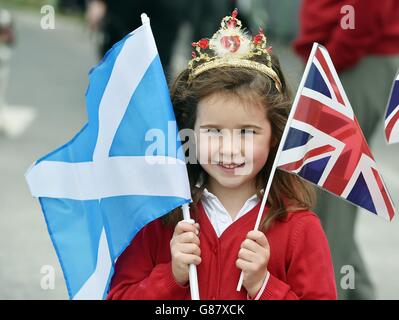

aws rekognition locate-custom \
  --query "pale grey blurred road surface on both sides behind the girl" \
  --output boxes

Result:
[0,1,399,299]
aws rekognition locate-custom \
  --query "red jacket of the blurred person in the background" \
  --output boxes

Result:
[294,0,399,72]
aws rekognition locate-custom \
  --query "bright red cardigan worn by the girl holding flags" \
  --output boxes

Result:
[108,202,336,300]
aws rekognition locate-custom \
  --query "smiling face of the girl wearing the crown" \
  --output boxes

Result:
[194,93,272,188]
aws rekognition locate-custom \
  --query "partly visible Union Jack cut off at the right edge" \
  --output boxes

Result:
[384,71,399,144]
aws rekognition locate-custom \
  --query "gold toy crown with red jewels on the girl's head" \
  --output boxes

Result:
[188,9,282,92]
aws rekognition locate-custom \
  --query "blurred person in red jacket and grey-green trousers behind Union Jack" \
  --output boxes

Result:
[293,0,399,299]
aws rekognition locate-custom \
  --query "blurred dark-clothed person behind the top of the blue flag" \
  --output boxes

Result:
[86,0,241,77]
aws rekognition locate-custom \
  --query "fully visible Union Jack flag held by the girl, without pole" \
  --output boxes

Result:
[277,43,394,220]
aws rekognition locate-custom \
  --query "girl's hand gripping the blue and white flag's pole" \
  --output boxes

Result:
[170,221,201,286]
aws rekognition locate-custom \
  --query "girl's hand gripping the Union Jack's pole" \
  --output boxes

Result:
[236,230,270,298]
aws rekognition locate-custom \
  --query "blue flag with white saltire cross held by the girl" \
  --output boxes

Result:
[26,17,191,299]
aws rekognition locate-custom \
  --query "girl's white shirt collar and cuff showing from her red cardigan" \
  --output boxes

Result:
[201,188,270,300]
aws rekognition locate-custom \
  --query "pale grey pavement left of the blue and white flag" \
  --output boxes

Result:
[0,10,96,299]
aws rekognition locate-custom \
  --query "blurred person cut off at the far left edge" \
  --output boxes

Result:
[0,9,15,133]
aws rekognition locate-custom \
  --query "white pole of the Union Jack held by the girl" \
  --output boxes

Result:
[237,42,318,291]
